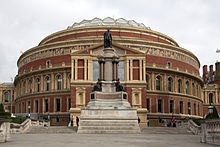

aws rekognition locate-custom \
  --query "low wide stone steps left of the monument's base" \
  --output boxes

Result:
[26,126,76,134]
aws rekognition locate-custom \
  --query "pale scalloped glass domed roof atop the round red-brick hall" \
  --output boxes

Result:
[67,17,150,30]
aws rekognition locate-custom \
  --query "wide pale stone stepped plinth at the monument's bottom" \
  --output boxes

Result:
[78,108,140,134]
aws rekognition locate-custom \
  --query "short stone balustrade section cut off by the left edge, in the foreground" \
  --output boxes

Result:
[0,118,10,142]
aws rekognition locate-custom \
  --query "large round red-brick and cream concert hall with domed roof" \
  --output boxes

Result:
[14,17,203,126]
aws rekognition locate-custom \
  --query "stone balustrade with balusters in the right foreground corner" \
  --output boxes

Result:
[200,119,220,145]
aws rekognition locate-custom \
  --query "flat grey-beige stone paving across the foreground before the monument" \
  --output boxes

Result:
[0,128,218,147]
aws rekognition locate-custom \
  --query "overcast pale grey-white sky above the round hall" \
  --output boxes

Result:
[0,0,220,82]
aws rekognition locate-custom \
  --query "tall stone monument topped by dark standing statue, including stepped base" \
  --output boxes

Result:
[78,29,140,134]
